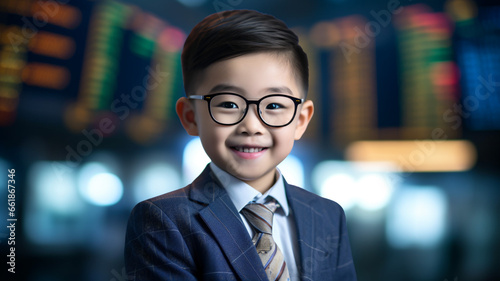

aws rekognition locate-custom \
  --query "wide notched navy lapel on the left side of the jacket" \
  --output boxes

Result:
[190,166,267,280]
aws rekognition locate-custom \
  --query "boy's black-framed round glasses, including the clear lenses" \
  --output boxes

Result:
[189,93,304,127]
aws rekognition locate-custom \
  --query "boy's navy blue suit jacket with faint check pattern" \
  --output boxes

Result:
[125,166,356,281]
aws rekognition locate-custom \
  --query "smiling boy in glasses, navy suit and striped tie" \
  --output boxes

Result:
[125,10,356,281]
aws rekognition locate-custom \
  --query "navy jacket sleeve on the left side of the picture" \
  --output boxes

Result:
[125,201,197,281]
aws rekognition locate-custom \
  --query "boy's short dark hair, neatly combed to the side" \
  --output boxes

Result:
[182,10,309,95]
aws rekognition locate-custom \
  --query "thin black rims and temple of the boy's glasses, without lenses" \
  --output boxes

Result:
[188,92,305,128]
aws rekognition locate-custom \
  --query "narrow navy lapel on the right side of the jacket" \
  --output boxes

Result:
[285,181,315,280]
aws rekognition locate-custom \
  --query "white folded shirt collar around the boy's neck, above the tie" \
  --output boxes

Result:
[210,162,289,216]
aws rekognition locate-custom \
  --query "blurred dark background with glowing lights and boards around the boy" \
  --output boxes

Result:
[0,0,500,281]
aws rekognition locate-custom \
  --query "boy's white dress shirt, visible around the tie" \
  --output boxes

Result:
[210,162,299,281]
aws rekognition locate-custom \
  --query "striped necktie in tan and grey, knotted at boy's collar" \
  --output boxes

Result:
[241,199,290,281]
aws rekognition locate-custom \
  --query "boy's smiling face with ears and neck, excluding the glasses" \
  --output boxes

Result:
[177,53,313,192]
